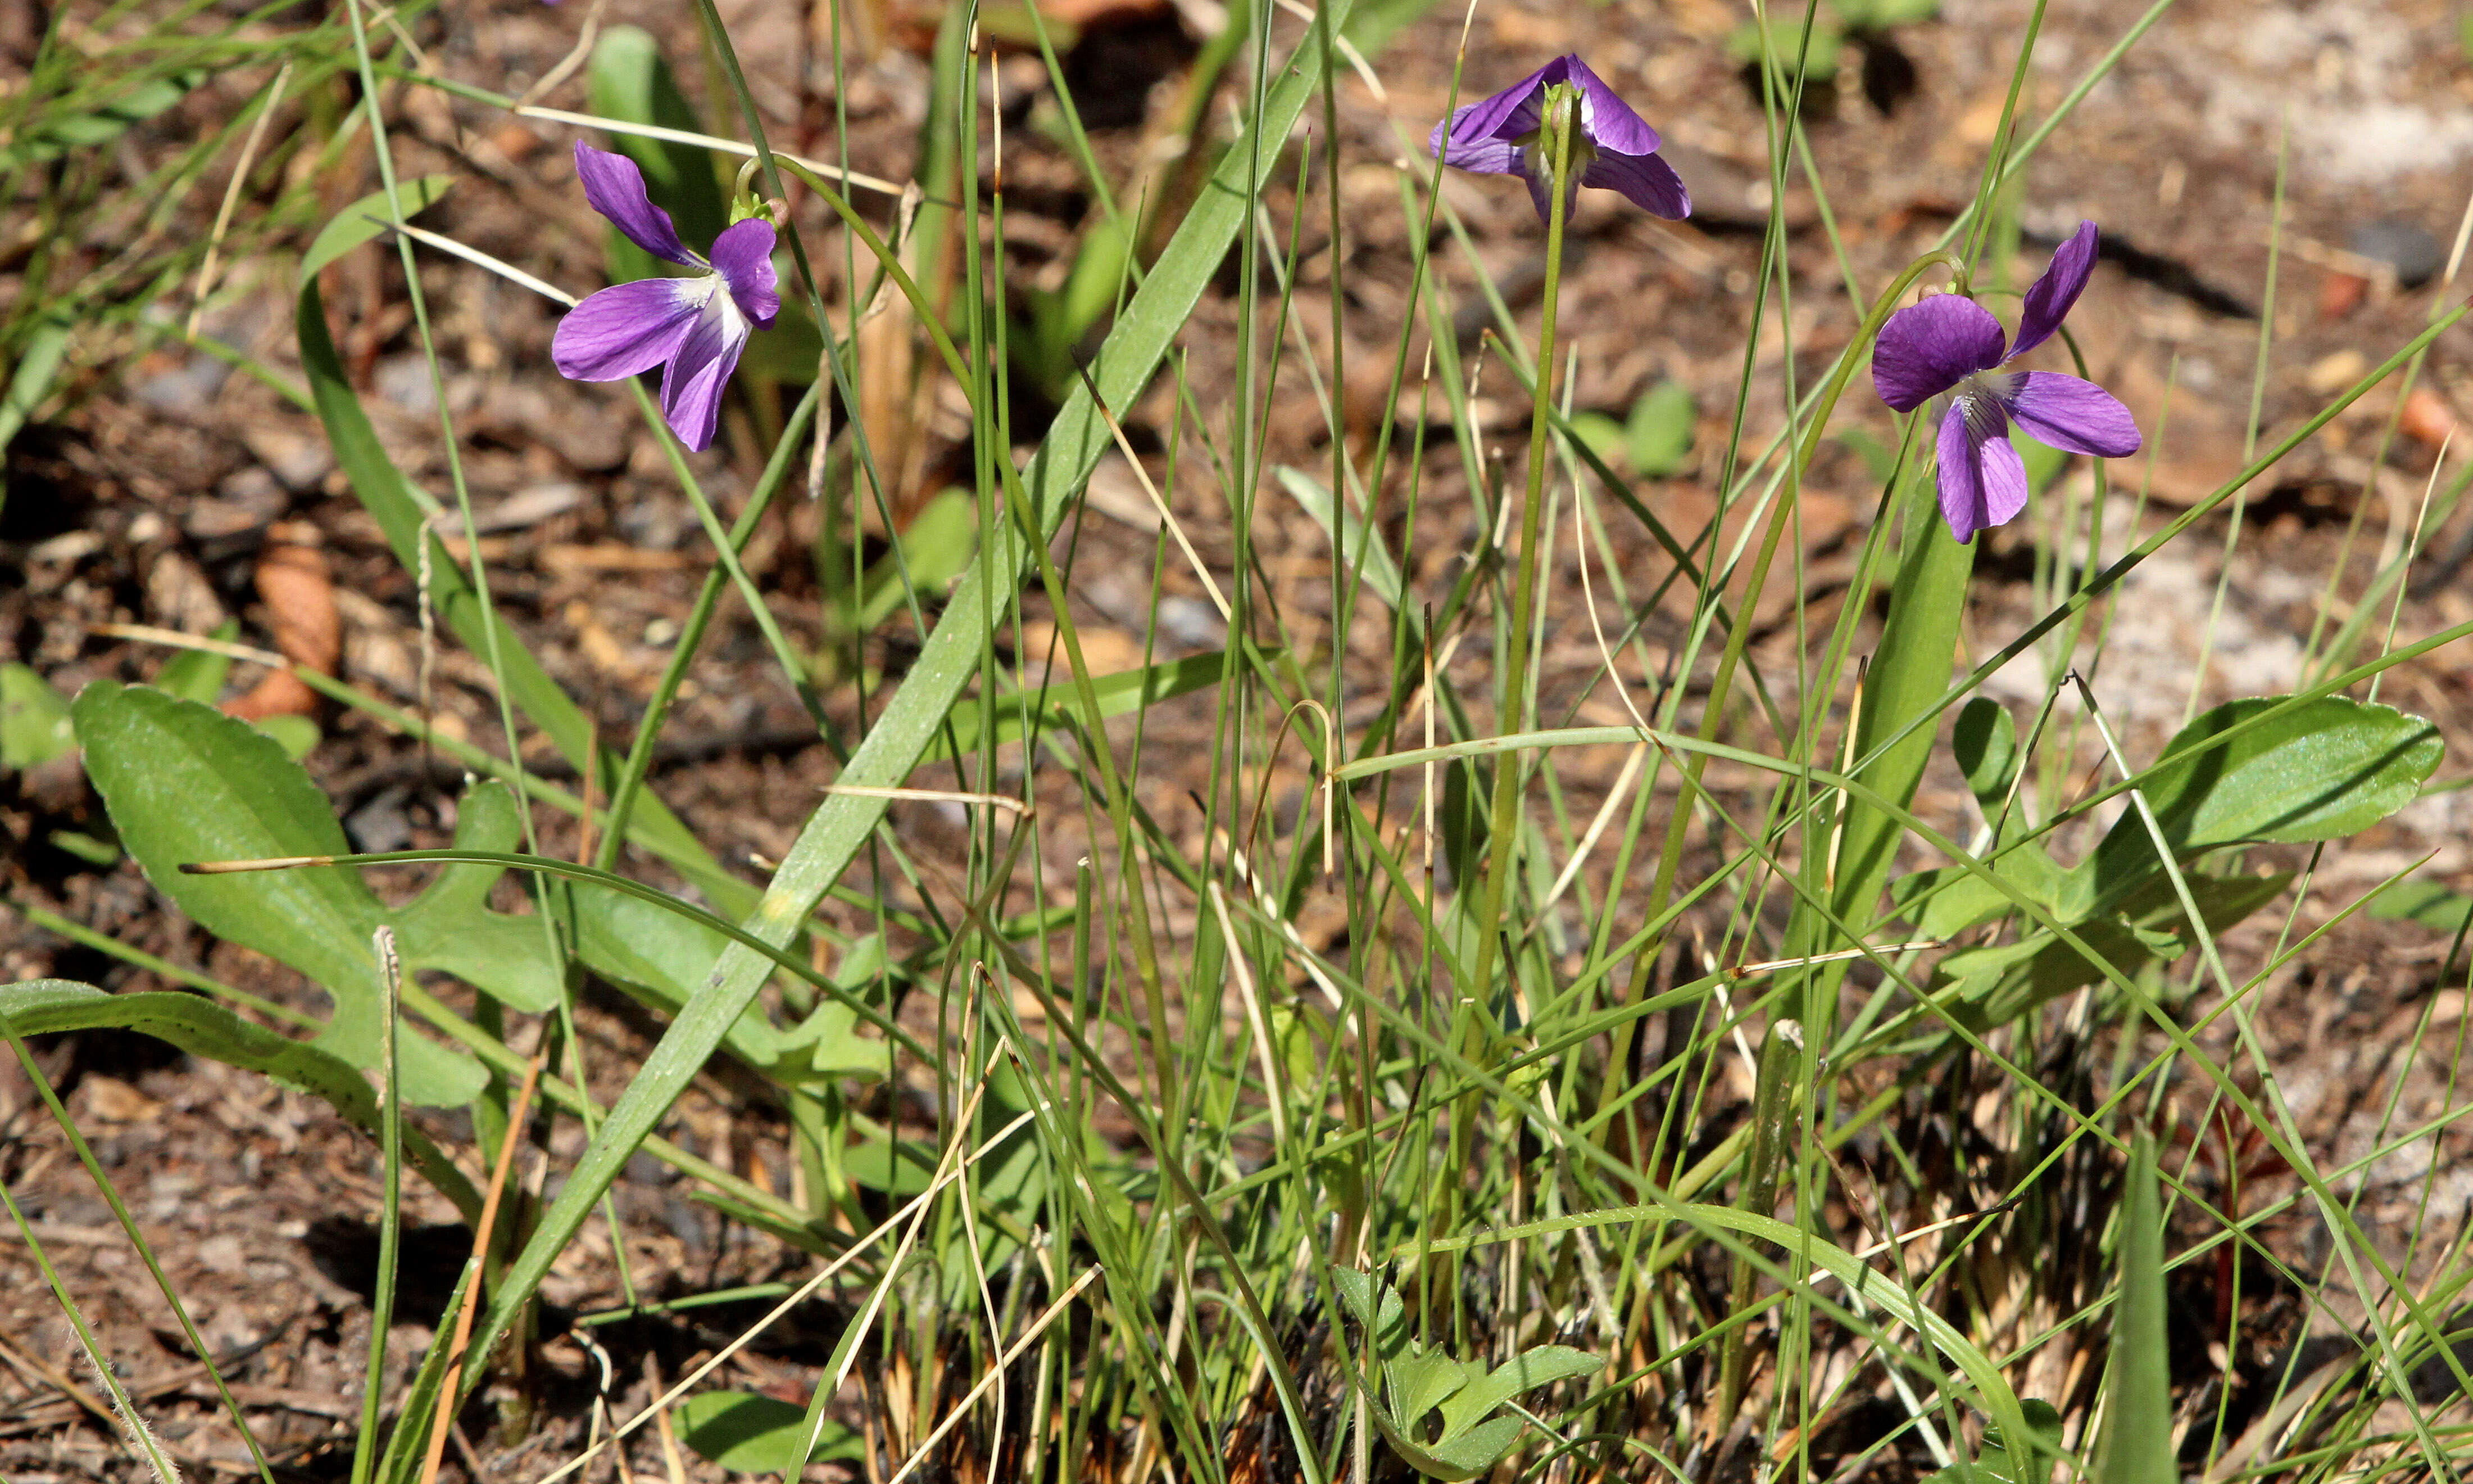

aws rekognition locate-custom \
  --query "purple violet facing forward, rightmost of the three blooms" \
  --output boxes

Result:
[1872,223,2139,542]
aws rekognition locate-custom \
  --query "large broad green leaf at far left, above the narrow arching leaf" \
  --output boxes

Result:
[72,680,487,1106]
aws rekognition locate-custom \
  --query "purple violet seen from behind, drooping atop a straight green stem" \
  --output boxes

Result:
[1427,57,1691,223]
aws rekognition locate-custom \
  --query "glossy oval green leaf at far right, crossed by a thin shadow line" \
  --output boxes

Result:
[2080,695,2446,900]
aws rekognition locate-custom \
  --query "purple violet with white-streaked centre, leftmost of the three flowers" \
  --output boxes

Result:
[549,141,782,450]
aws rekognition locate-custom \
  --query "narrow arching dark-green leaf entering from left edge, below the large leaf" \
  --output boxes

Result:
[0,979,480,1222]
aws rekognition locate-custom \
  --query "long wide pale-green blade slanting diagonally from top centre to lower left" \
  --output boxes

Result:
[465,29,1348,1385]
